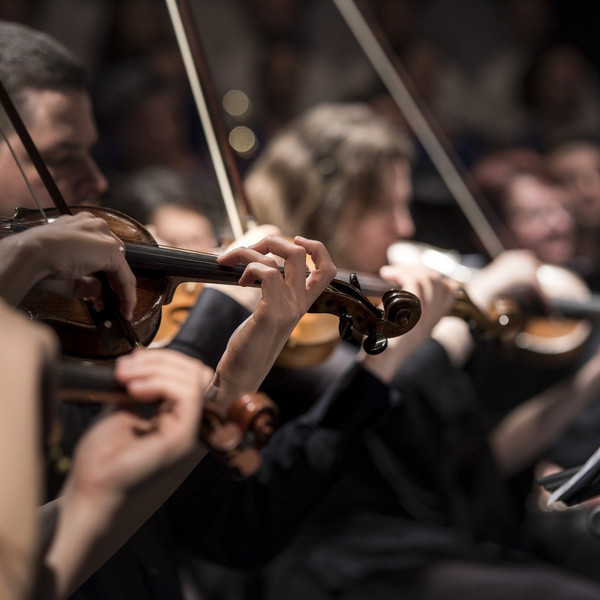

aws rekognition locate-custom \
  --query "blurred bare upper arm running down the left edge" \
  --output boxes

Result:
[0,302,56,598]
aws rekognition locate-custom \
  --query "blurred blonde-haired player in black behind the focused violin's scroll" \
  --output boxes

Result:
[220,104,600,599]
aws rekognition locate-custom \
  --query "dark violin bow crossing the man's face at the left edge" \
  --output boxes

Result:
[0,79,142,348]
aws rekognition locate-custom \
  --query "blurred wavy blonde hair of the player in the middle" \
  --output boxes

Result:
[246,104,413,261]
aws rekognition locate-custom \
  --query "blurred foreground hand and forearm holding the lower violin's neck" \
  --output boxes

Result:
[45,350,212,598]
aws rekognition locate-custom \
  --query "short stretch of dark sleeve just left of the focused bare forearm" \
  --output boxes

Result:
[168,288,250,369]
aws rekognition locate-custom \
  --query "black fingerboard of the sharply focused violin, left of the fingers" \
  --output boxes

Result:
[125,242,250,285]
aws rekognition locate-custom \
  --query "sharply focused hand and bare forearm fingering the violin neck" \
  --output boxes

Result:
[216,236,336,398]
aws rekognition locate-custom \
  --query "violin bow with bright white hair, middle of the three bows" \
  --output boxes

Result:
[166,0,253,238]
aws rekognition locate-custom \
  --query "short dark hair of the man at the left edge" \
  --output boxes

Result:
[0,21,88,127]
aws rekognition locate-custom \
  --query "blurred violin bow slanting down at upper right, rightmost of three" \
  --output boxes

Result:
[333,0,508,258]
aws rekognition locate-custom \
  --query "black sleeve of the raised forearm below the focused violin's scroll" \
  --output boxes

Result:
[166,366,398,568]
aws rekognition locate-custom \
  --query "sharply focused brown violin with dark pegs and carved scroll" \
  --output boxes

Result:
[7,207,421,359]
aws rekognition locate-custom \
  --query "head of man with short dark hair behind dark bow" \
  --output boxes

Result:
[0,23,108,217]
